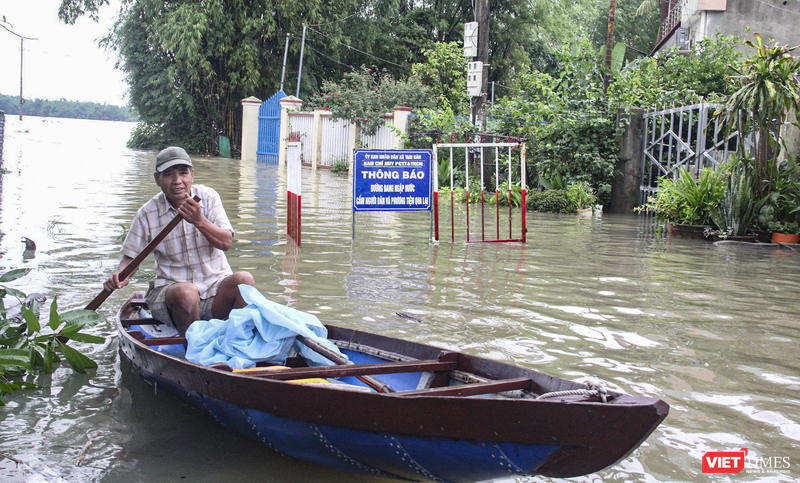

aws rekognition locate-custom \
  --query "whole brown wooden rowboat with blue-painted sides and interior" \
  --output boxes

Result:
[117,292,669,482]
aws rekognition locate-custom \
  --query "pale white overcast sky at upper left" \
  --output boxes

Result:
[0,0,128,106]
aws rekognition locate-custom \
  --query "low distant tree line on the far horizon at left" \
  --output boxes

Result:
[0,94,139,121]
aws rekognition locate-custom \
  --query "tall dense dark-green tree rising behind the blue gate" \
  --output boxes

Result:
[106,0,352,154]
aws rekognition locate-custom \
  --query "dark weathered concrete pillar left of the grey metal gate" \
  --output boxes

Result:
[603,108,644,213]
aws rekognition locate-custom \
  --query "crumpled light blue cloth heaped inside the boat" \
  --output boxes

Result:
[186,284,340,369]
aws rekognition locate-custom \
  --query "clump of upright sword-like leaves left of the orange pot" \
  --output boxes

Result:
[710,156,764,236]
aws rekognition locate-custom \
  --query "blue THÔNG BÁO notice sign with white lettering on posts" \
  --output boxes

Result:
[353,149,434,237]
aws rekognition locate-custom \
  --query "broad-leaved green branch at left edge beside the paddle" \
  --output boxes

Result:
[0,269,105,404]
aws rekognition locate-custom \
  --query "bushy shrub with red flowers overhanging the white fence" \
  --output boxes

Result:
[311,67,436,135]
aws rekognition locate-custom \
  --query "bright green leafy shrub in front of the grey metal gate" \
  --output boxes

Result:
[637,168,726,225]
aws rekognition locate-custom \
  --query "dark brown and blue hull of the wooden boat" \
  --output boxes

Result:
[119,296,668,482]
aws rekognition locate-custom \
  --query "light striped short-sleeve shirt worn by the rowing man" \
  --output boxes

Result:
[122,185,233,299]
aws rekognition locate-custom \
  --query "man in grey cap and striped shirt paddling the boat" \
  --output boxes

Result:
[104,147,255,335]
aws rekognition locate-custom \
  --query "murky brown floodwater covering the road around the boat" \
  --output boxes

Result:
[0,117,800,482]
